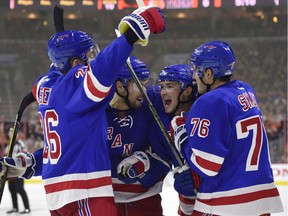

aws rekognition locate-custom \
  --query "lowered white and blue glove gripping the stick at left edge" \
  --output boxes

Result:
[0,152,36,180]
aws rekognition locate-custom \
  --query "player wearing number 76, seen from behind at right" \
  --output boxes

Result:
[171,41,283,216]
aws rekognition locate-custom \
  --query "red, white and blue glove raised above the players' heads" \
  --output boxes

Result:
[118,6,165,46]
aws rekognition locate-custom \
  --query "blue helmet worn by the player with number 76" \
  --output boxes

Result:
[189,41,236,78]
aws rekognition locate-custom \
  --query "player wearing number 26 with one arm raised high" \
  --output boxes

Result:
[0,6,165,216]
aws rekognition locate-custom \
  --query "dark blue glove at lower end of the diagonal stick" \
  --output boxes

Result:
[173,164,200,196]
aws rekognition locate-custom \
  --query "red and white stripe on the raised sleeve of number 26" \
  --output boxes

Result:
[84,67,112,102]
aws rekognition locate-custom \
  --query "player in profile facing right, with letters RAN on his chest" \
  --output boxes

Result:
[106,56,170,216]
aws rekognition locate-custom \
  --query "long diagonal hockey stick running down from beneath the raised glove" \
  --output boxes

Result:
[115,29,184,167]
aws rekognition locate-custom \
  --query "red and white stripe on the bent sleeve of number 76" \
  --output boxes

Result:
[191,149,224,176]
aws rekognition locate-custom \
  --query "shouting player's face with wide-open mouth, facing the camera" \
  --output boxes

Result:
[160,81,181,114]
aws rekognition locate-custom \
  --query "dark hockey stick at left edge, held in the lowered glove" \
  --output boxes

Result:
[0,92,35,204]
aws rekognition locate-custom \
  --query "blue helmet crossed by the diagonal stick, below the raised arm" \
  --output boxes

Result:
[118,56,150,86]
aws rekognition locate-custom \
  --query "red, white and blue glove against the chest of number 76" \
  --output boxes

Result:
[170,112,188,154]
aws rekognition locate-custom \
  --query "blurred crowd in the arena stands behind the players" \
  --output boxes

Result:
[0,3,288,163]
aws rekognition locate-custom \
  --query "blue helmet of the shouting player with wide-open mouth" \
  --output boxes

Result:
[159,64,193,90]
